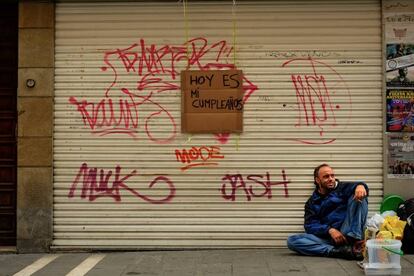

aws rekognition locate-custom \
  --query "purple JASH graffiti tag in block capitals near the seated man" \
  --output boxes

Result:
[221,170,290,201]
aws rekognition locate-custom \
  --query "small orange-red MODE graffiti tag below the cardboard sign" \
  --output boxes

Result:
[175,146,224,171]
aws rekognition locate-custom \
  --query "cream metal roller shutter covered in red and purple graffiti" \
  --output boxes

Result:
[53,0,383,249]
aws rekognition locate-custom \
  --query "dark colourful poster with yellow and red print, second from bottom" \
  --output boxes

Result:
[386,88,414,132]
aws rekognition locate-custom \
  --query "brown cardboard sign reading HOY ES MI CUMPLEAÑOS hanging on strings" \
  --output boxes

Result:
[181,70,243,133]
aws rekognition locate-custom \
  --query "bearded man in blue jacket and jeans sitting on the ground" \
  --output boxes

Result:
[287,164,368,260]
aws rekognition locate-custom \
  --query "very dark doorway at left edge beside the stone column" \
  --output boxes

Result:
[0,2,18,246]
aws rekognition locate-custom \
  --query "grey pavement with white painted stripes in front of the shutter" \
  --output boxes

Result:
[0,249,414,276]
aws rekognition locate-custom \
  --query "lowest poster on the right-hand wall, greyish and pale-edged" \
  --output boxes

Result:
[388,133,414,179]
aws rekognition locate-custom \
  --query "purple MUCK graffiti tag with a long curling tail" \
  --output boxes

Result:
[68,163,175,204]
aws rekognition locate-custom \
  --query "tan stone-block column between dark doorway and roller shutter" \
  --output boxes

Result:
[17,0,54,253]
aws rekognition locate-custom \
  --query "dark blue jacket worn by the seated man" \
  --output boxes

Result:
[305,181,368,238]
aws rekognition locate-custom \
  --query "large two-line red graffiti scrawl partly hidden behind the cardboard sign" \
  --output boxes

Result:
[69,37,257,144]
